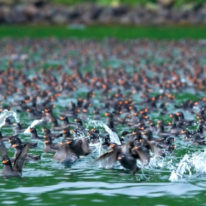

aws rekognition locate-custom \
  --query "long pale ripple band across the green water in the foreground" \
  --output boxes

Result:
[5,181,205,197]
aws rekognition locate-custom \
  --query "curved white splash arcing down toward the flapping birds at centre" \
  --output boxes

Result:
[88,119,121,145]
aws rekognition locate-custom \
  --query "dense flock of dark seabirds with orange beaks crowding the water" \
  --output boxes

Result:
[0,39,206,177]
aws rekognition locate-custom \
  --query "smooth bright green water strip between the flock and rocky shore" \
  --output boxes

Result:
[0,25,206,40]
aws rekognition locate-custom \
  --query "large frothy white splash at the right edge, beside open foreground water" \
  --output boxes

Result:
[169,150,206,181]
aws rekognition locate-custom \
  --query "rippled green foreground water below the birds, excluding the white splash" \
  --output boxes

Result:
[0,147,206,206]
